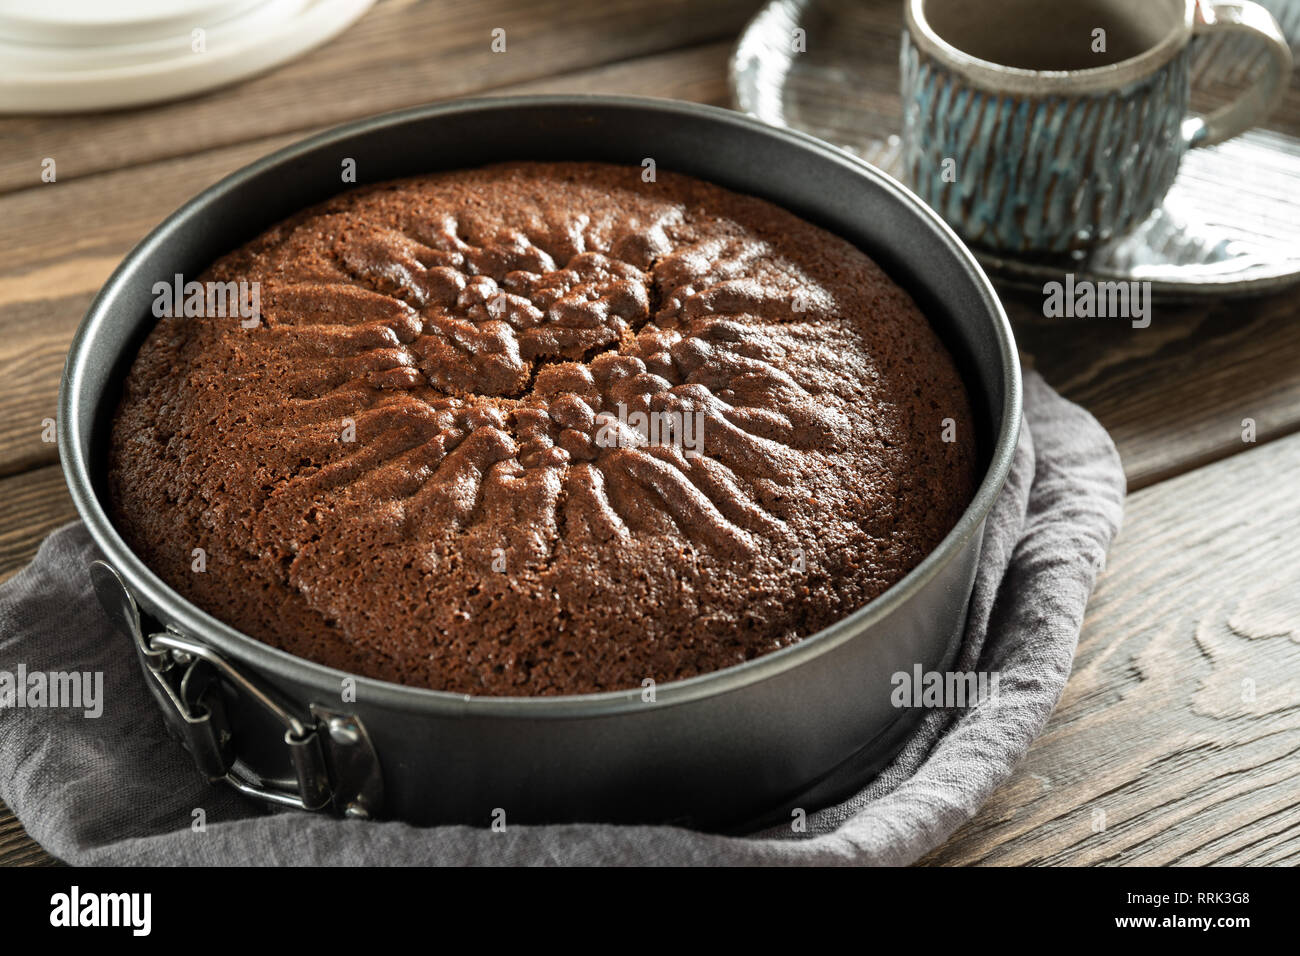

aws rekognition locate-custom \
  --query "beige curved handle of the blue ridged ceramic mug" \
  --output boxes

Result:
[1183,0,1292,147]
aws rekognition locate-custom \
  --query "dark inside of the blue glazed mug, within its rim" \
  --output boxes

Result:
[928,0,1178,70]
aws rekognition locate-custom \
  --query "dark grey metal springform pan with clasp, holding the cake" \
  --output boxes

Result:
[59,96,1021,829]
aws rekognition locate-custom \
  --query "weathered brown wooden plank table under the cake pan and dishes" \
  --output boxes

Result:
[0,0,1300,864]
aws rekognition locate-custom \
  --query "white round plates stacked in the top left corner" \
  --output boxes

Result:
[0,0,374,113]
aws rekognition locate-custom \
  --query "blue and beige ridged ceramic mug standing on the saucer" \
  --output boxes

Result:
[901,0,1291,255]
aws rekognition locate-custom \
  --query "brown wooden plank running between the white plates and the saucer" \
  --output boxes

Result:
[0,0,761,193]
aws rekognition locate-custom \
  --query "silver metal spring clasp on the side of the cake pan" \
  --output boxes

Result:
[90,561,384,818]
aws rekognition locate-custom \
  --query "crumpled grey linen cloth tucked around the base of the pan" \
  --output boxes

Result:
[0,372,1125,865]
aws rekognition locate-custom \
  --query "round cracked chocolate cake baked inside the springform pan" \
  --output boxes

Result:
[108,163,976,696]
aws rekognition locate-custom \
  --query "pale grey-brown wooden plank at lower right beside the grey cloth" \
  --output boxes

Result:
[926,436,1300,865]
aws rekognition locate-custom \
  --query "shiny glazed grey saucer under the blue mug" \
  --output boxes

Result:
[729,0,1300,298]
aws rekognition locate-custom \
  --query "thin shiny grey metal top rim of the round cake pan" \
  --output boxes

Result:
[57,94,1022,719]
